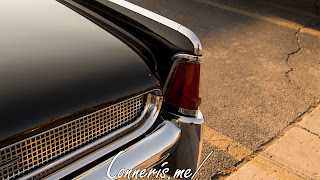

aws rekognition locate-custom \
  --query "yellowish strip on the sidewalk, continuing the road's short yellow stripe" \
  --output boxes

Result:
[249,154,305,180]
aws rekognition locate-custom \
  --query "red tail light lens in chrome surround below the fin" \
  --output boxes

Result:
[165,62,201,110]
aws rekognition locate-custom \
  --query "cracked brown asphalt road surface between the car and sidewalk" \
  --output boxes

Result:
[129,0,320,179]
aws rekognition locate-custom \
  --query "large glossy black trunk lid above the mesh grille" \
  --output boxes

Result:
[0,0,159,143]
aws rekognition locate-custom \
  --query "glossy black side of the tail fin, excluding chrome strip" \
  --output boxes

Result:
[59,0,194,82]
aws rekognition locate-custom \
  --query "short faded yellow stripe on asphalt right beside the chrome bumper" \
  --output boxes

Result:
[204,126,252,161]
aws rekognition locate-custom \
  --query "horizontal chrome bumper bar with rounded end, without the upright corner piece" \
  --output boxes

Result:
[76,121,181,180]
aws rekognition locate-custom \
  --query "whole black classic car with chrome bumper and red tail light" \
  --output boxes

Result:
[0,0,204,179]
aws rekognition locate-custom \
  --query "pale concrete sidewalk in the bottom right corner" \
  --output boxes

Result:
[227,107,320,180]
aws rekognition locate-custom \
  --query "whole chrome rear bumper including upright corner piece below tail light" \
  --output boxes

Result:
[48,111,204,180]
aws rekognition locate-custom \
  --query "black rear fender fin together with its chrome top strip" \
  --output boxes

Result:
[59,0,202,84]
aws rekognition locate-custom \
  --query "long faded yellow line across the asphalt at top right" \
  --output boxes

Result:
[196,0,320,37]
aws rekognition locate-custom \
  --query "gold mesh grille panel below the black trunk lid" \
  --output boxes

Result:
[0,96,144,179]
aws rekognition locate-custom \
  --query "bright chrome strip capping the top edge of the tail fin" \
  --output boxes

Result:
[106,0,202,55]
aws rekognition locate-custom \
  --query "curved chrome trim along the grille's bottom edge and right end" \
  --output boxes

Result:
[21,90,163,179]
